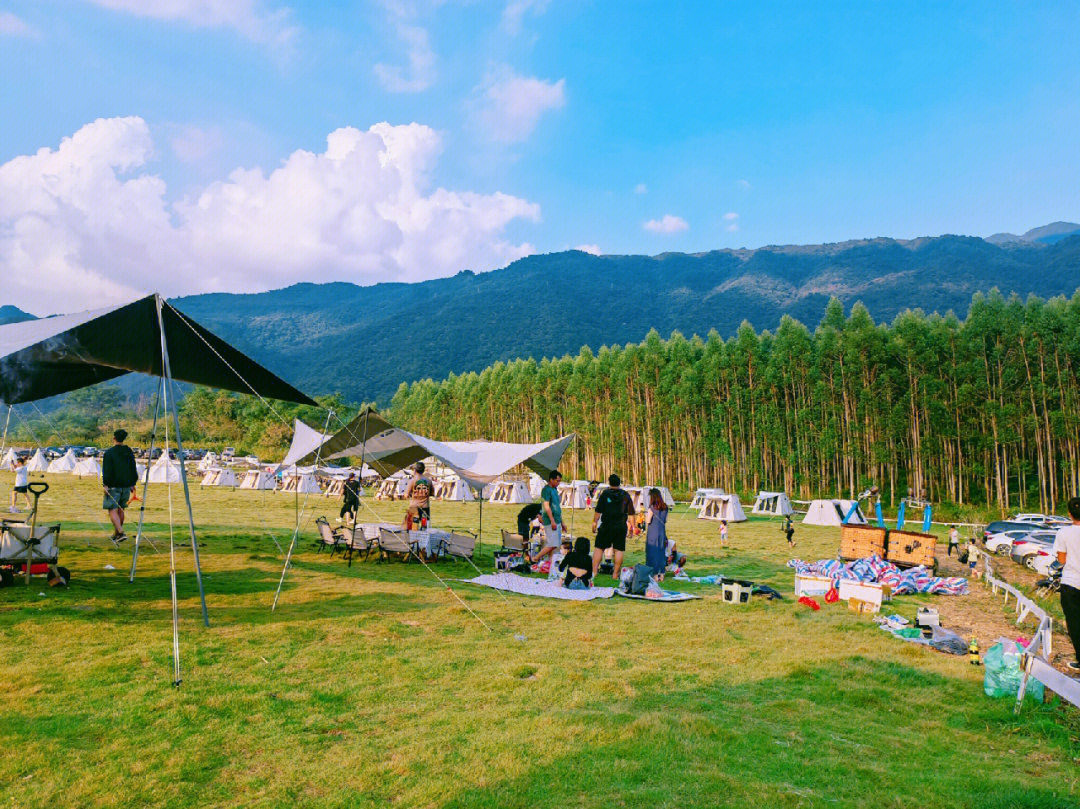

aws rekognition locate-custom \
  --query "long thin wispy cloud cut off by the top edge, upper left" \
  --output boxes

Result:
[80,0,298,45]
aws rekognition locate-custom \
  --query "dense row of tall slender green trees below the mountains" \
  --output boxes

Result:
[392,293,1080,510]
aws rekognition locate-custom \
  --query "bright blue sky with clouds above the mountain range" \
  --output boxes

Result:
[0,0,1080,309]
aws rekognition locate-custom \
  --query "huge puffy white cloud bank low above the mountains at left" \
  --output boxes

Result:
[0,118,540,311]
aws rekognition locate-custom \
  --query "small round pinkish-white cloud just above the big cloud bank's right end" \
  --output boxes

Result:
[471,67,566,144]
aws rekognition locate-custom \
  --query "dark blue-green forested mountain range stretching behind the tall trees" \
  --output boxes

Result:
[6,223,1080,404]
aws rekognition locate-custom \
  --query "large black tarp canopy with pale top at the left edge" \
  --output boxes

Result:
[0,295,318,406]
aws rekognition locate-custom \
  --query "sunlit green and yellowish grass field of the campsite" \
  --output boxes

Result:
[0,474,1080,809]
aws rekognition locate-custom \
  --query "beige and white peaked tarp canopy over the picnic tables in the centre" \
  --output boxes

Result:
[283,409,573,489]
